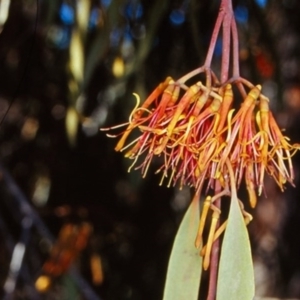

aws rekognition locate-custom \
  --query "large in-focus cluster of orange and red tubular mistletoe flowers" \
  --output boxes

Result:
[102,77,299,207]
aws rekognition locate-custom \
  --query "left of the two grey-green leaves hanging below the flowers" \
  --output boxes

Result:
[163,197,202,300]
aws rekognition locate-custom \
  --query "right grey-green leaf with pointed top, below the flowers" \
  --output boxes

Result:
[217,197,255,300]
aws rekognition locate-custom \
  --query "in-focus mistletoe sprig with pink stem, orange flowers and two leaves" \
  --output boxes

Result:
[102,0,299,300]
